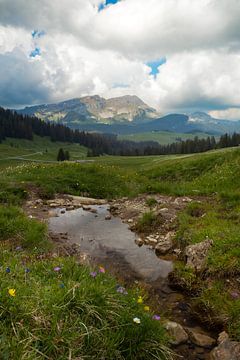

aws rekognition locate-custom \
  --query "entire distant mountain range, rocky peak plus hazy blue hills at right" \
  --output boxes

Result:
[18,95,240,135]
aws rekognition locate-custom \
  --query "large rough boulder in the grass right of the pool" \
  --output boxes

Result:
[185,239,213,271]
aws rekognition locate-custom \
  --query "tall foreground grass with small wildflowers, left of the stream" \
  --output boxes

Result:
[0,248,171,360]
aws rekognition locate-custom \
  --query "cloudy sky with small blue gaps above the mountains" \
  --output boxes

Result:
[0,0,240,120]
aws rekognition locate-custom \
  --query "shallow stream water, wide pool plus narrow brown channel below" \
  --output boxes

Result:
[49,205,215,360]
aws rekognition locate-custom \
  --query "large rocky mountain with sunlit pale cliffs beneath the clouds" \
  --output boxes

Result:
[18,95,159,127]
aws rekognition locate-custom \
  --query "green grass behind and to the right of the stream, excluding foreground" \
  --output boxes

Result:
[0,141,240,340]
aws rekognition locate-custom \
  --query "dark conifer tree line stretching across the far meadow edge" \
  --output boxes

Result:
[0,107,240,156]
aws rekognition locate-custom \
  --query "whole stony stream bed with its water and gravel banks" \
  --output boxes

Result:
[25,191,238,360]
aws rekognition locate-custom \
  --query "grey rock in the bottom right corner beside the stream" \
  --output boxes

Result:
[209,340,240,360]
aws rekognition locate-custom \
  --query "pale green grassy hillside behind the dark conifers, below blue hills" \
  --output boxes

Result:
[118,131,214,145]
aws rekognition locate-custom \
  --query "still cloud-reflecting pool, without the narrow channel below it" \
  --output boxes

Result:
[49,205,173,282]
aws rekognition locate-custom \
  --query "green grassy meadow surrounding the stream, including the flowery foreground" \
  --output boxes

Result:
[0,137,240,359]
